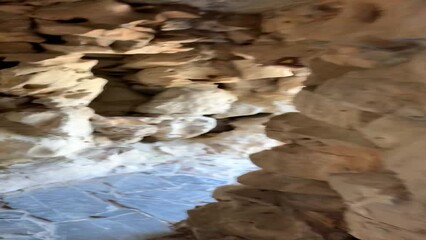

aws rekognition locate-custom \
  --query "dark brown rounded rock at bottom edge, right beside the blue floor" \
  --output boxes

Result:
[188,202,322,240]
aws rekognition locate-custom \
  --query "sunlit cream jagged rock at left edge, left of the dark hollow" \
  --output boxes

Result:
[0,57,106,107]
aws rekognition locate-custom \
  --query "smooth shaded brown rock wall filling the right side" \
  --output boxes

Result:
[187,0,426,240]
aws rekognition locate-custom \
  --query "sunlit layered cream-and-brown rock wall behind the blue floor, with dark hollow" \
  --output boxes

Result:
[0,0,309,192]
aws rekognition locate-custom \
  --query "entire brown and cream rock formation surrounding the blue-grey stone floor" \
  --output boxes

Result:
[0,0,426,240]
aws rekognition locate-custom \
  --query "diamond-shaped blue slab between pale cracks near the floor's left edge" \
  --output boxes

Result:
[4,187,114,222]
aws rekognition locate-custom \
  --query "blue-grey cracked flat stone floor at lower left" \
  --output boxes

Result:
[0,171,231,240]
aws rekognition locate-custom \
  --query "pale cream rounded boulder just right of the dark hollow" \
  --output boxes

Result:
[136,87,237,116]
